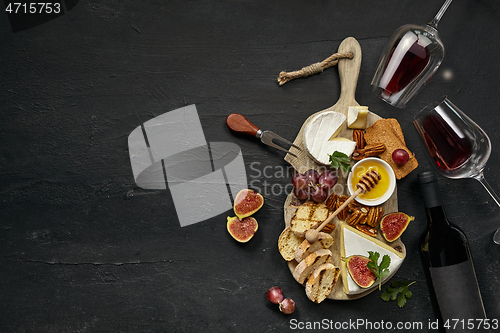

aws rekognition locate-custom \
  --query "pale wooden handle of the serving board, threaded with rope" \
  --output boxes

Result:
[336,37,361,111]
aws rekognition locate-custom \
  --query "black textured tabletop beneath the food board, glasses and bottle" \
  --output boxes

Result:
[0,0,500,332]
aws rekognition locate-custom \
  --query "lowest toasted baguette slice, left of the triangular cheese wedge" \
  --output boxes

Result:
[306,263,340,303]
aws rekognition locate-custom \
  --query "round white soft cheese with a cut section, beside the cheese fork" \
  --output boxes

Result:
[303,111,356,165]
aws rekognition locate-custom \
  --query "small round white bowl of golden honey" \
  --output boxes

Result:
[349,158,395,204]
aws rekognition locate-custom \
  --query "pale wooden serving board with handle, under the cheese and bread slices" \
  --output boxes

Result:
[284,37,406,300]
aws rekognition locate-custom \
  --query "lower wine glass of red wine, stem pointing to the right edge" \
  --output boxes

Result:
[413,97,500,244]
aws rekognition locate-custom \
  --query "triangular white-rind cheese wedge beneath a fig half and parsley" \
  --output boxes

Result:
[340,222,404,295]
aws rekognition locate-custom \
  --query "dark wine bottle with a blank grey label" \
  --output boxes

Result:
[417,171,489,332]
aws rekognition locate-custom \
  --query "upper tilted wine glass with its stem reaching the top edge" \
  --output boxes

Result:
[371,0,452,108]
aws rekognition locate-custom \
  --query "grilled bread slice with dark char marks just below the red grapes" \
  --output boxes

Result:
[290,201,331,237]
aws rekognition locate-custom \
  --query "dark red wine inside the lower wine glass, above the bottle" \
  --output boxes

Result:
[422,115,473,172]
